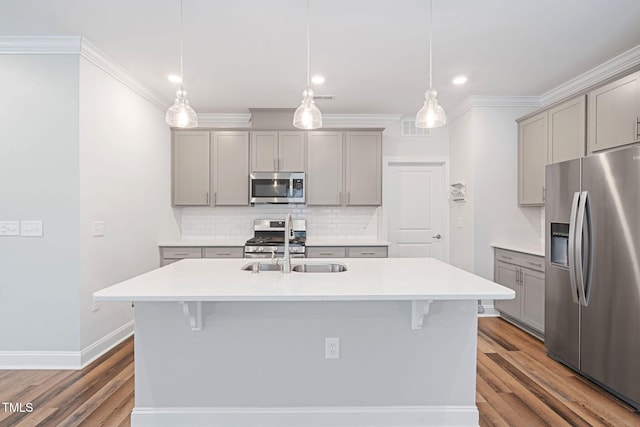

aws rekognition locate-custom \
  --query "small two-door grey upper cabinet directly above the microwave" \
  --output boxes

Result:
[251,131,305,172]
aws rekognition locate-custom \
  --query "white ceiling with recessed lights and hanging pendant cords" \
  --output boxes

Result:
[0,0,640,114]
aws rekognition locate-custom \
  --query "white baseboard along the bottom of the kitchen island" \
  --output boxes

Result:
[131,406,479,427]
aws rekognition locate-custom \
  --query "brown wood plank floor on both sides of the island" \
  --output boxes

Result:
[0,318,640,427]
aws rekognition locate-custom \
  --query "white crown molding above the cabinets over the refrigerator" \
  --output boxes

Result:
[540,45,640,106]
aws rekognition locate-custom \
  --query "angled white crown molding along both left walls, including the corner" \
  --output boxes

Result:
[0,36,171,110]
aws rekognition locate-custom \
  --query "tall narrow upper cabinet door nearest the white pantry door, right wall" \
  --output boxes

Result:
[518,111,547,205]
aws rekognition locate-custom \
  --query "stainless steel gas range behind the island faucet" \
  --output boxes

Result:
[244,219,307,258]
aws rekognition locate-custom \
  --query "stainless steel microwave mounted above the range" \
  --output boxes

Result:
[249,172,305,203]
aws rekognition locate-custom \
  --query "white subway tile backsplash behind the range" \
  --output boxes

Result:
[181,205,381,240]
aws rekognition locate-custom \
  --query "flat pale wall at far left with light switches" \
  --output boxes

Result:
[0,55,80,351]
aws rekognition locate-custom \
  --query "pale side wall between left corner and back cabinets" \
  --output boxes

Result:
[79,58,179,356]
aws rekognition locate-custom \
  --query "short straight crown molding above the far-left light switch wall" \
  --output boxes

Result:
[0,36,82,55]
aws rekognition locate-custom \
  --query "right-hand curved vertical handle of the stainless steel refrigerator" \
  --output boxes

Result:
[576,191,593,307]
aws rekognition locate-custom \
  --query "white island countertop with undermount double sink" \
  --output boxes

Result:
[93,258,515,301]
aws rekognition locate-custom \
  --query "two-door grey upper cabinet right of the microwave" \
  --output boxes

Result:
[306,131,382,206]
